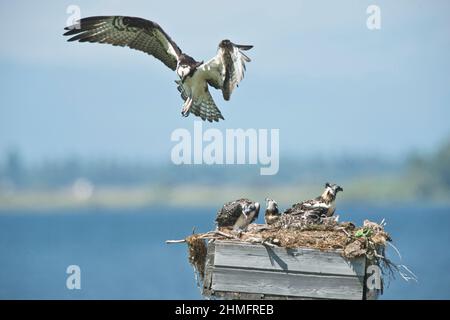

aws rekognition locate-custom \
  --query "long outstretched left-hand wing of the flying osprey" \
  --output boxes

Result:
[64,16,181,70]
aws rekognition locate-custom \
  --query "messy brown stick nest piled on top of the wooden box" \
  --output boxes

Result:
[166,217,416,288]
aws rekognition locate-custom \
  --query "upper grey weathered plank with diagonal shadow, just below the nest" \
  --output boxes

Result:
[214,241,365,276]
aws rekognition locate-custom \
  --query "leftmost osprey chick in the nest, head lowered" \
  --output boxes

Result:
[216,199,259,230]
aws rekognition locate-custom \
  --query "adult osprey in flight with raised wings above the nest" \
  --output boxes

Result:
[64,16,253,122]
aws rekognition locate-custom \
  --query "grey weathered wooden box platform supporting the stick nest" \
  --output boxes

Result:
[203,240,376,300]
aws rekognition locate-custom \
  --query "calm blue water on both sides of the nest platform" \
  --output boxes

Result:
[0,205,450,299]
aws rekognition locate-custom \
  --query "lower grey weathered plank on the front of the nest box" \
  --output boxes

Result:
[211,268,364,300]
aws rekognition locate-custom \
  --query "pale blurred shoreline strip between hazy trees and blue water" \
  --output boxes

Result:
[0,182,450,213]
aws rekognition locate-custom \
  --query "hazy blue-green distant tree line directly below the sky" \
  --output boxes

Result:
[0,140,450,192]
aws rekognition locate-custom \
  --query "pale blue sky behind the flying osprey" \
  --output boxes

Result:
[0,0,450,161]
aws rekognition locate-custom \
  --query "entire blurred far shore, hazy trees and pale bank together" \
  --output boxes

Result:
[0,141,450,210]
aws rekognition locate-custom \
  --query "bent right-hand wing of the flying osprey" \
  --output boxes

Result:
[199,40,253,100]
